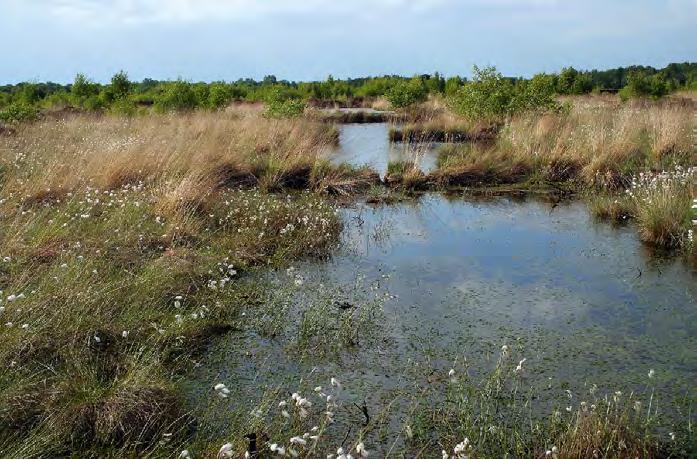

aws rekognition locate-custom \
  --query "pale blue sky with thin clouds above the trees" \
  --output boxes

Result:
[0,0,697,84]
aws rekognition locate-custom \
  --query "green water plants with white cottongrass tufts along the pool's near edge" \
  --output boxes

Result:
[192,345,694,459]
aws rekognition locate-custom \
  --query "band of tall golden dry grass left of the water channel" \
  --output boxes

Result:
[0,106,336,200]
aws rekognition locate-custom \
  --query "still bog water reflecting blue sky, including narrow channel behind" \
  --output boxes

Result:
[191,124,697,452]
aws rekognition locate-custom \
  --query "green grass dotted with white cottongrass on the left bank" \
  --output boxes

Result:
[0,187,341,457]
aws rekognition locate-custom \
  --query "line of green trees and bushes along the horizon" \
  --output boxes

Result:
[0,63,697,121]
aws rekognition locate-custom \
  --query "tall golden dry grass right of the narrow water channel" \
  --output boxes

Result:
[390,94,697,190]
